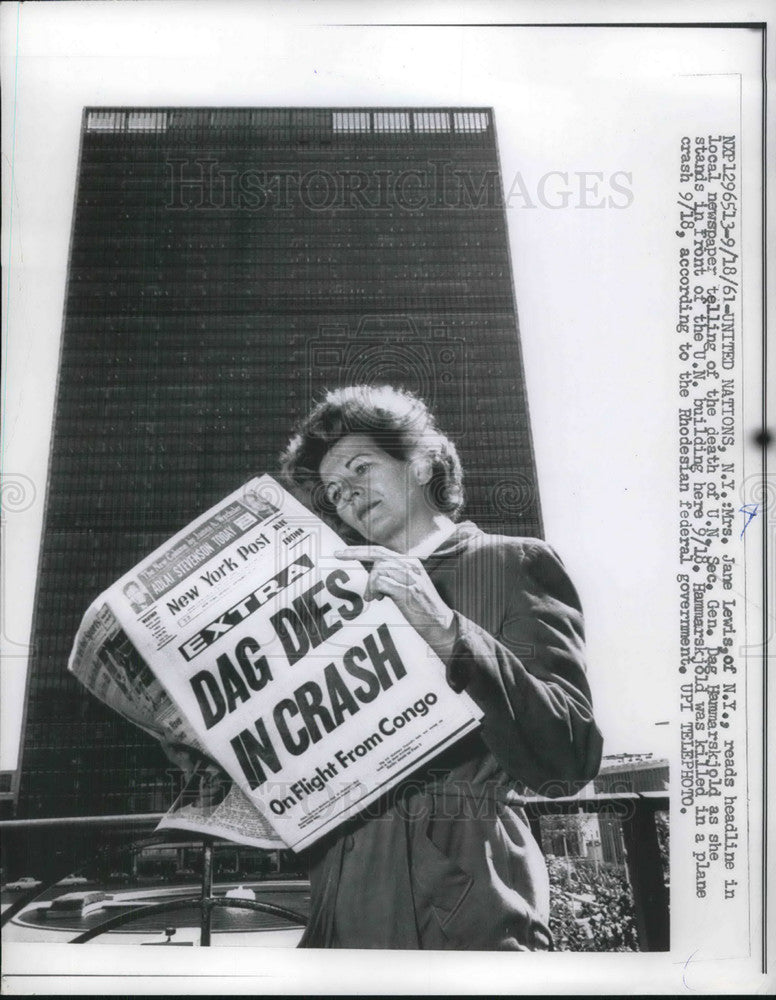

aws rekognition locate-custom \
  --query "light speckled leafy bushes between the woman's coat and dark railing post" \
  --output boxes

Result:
[547,857,638,951]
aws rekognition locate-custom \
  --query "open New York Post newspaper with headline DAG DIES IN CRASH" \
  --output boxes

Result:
[69,476,481,850]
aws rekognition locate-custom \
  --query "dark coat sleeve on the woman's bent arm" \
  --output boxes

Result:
[448,540,603,797]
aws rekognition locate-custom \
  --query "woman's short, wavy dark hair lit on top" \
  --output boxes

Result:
[280,385,464,521]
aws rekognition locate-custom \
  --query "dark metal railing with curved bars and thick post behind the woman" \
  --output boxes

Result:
[0,792,670,951]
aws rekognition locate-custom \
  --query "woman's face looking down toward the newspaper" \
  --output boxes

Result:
[318,434,434,552]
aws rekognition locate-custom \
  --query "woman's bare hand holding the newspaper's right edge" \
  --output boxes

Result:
[335,545,456,660]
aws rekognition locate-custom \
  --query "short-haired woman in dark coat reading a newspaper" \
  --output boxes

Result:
[282,386,602,951]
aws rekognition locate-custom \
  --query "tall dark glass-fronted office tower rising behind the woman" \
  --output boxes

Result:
[17,108,541,844]
